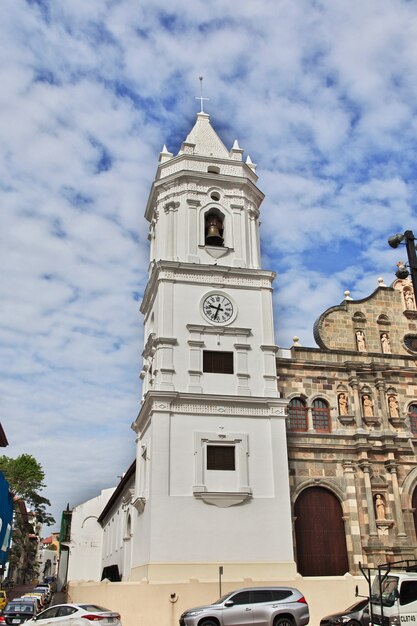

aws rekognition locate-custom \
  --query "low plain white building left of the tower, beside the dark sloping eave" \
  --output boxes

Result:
[67,487,115,582]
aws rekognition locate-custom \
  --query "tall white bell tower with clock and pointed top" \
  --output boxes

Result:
[131,112,295,581]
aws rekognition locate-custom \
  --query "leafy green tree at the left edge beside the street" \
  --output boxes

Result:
[0,454,55,526]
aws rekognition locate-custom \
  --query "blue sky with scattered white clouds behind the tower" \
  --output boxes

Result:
[0,0,417,518]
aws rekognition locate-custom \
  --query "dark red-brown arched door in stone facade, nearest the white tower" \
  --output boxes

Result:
[294,487,349,576]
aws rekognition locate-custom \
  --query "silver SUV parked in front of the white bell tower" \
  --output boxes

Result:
[180,587,310,626]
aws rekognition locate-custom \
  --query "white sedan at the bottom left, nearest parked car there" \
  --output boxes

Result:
[25,604,122,626]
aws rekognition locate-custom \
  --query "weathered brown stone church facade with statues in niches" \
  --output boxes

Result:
[277,279,417,576]
